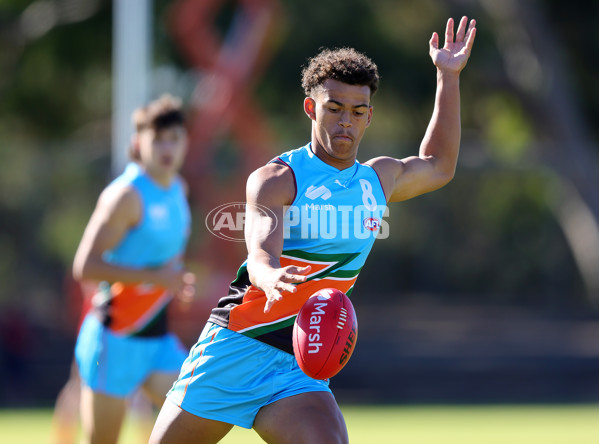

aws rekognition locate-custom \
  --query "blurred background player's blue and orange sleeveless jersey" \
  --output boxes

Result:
[94,163,191,336]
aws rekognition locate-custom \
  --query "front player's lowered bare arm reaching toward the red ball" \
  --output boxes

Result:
[245,164,310,313]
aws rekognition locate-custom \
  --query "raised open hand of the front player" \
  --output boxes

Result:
[429,16,476,73]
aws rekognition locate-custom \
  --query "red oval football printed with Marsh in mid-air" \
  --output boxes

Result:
[293,288,358,379]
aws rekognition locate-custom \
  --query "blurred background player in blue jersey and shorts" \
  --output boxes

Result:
[73,95,195,443]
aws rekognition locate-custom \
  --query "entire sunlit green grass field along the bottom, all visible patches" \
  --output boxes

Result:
[0,405,599,444]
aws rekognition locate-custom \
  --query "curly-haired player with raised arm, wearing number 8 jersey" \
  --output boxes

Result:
[150,17,476,444]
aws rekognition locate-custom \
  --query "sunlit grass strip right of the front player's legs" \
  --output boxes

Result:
[343,405,599,444]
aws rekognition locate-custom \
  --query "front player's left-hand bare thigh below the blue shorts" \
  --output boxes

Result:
[149,401,233,444]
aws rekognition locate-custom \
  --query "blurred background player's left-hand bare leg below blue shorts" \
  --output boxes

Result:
[81,385,127,444]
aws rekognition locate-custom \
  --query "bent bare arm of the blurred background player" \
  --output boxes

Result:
[73,186,190,291]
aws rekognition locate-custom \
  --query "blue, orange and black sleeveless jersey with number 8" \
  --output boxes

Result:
[210,144,387,353]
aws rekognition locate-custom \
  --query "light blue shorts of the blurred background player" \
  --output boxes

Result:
[75,314,187,397]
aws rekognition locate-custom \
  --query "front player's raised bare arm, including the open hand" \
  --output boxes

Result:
[367,17,476,202]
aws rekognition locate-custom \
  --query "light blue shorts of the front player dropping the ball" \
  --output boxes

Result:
[167,322,331,429]
